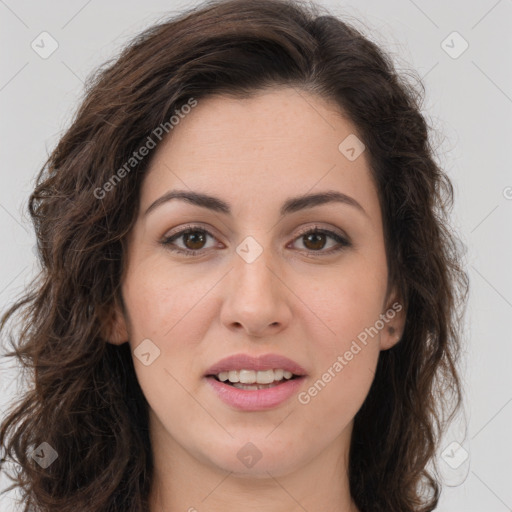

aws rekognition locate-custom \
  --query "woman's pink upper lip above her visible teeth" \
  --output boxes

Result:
[206,354,306,375]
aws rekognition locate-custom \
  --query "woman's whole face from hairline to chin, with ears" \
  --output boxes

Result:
[109,88,403,477]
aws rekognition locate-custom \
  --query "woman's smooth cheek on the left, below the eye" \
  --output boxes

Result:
[123,258,215,394]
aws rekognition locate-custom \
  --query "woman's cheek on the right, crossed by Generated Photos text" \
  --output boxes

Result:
[299,257,386,410]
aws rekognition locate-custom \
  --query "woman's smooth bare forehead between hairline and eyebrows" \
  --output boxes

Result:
[141,88,378,226]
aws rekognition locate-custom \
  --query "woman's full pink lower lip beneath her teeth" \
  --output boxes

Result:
[206,377,304,411]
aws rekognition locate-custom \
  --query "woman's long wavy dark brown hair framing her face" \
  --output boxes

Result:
[0,0,469,512]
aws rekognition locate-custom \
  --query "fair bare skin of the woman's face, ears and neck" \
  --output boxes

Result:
[109,87,405,512]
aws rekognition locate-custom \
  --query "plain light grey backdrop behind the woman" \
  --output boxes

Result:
[0,0,512,512]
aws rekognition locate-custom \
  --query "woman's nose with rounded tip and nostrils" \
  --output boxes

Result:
[221,245,293,337]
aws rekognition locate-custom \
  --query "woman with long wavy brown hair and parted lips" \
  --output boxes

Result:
[0,0,468,512]
